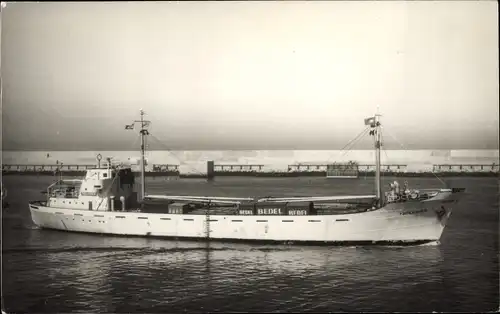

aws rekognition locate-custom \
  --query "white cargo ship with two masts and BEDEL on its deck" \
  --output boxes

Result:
[29,110,465,245]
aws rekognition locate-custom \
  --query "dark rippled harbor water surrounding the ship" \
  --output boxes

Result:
[2,178,499,313]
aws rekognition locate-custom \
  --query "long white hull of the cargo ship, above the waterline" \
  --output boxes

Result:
[30,196,458,242]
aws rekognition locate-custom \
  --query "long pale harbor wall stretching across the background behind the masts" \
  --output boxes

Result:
[2,150,499,175]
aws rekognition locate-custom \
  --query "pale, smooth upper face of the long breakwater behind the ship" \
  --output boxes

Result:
[1,149,500,169]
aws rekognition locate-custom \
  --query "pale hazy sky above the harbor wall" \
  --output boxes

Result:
[1,1,499,150]
